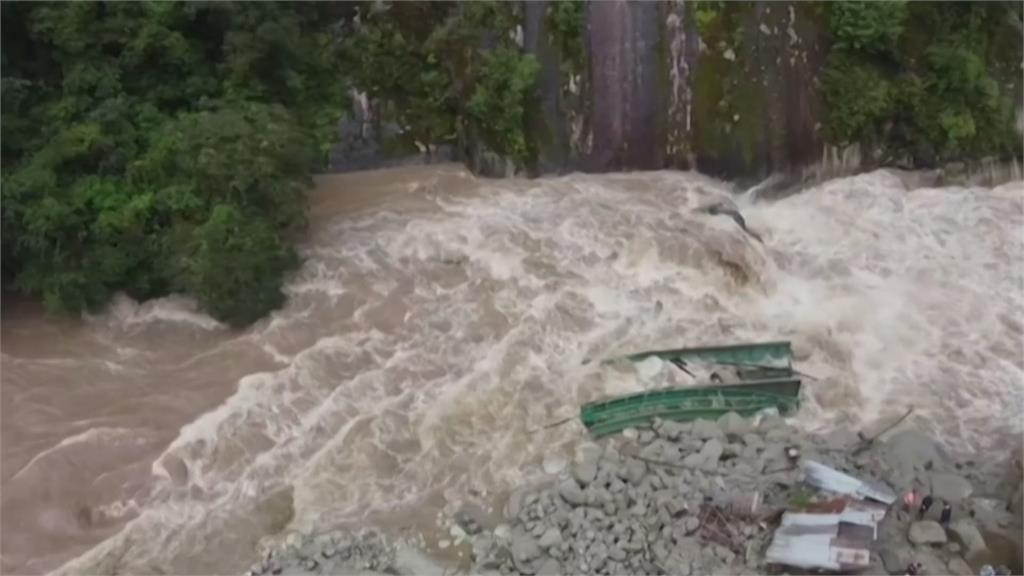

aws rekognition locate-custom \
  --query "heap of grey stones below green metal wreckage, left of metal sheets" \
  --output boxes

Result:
[473,413,851,576]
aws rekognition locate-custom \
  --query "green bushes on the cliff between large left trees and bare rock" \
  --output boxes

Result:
[348,0,538,166]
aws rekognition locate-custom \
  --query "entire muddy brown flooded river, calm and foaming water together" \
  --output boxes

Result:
[0,165,1024,574]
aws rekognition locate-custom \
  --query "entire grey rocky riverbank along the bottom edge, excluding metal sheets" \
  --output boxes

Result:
[251,414,1021,576]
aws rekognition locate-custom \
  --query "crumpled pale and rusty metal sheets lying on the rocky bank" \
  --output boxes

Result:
[765,460,896,572]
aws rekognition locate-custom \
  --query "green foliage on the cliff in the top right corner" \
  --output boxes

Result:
[822,1,1021,166]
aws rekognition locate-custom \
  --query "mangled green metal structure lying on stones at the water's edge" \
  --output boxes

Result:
[580,341,801,437]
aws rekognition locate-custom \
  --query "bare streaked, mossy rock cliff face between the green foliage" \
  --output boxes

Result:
[524,1,821,176]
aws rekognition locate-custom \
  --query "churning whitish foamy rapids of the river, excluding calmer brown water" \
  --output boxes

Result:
[49,169,1024,573]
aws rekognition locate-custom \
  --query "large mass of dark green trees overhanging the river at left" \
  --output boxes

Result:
[2,2,348,325]
